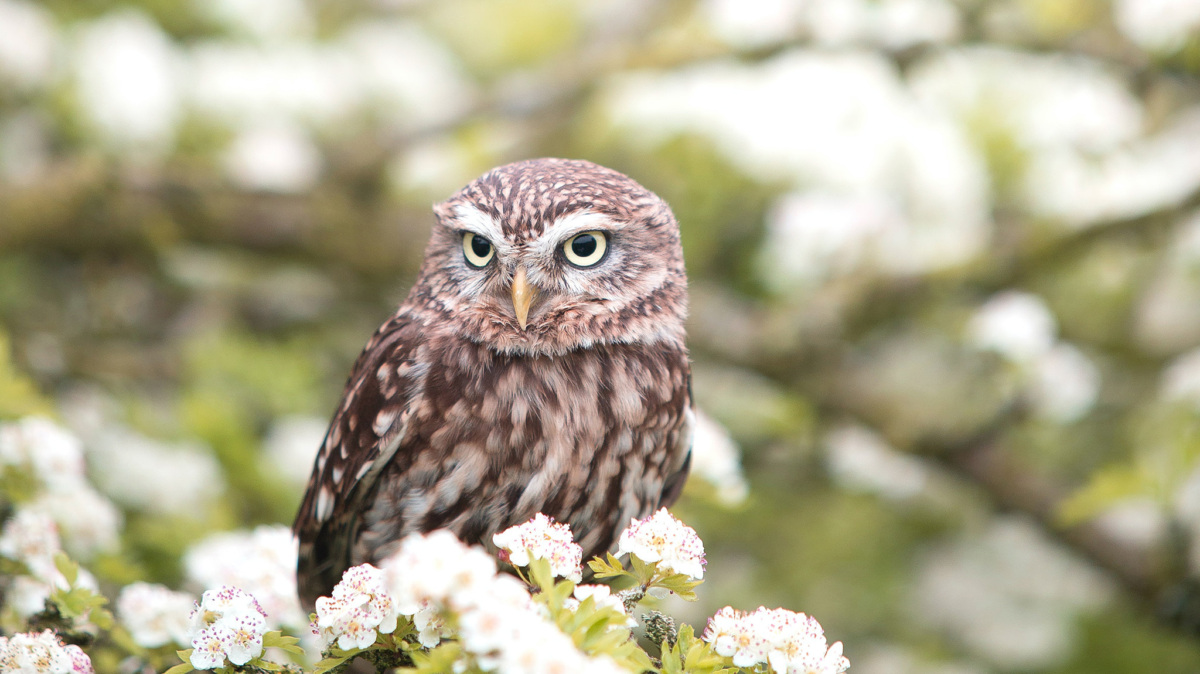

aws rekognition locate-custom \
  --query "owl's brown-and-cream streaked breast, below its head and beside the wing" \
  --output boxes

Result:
[364,342,690,559]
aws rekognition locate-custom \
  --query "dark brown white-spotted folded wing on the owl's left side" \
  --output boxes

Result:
[292,315,420,609]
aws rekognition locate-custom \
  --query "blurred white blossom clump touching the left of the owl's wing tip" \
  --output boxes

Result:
[184,525,308,631]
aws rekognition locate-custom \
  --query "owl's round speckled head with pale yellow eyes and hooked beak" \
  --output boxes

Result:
[409,158,688,354]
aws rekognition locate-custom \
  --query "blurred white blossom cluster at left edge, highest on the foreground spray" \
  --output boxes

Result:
[0,416,122,558]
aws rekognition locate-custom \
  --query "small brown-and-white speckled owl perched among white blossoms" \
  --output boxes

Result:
[293,158,694,608]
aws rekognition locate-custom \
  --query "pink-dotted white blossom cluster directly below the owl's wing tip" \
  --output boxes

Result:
[313,564,400,650]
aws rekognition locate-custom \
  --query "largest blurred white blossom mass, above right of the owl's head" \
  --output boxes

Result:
[604,50,991,280]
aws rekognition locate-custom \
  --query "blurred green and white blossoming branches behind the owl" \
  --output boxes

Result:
[0,0,1200,674]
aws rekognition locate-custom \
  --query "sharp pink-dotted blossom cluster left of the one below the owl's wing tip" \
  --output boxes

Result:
[191,585,266,669]
